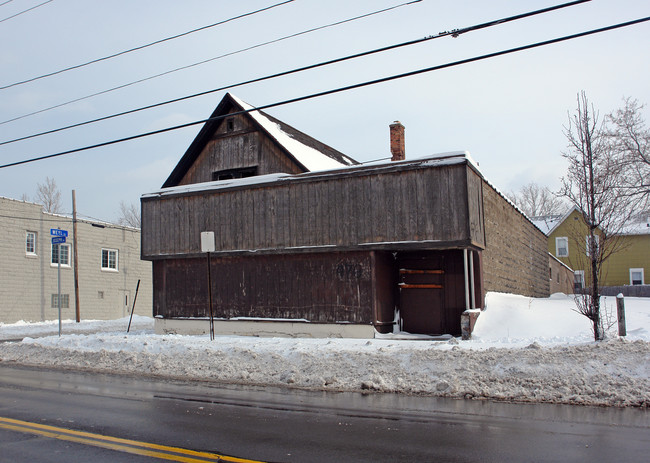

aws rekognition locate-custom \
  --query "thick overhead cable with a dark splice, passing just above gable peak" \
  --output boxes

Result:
[0,0,591,146]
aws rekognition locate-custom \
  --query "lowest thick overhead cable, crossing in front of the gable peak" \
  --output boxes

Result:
[0,16,650,169]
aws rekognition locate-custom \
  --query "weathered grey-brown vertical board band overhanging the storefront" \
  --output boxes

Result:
[142,163,484,259]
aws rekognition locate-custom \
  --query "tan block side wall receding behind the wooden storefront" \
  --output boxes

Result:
[483,182,550,297]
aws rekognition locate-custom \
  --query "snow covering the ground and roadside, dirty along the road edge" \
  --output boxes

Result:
[0,293,650,407]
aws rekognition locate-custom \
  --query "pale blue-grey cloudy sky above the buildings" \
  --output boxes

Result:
[0,0,650,225]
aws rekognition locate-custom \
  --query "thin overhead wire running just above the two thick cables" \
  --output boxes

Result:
[0,0,420,125]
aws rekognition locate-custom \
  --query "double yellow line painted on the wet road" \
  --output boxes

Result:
[0,417,262,463]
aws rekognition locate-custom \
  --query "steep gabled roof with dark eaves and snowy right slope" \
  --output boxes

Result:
[163,93,359,188]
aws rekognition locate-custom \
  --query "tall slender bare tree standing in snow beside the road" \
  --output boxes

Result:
[559,92,632,341]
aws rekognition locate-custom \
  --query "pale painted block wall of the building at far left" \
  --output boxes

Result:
[0,198,152,323]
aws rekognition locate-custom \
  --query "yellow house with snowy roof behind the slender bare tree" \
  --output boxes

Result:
[535,208,650,290]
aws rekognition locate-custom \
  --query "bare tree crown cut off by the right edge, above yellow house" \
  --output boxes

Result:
[606,98,650,208]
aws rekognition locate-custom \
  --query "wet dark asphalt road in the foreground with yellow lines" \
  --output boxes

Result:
[0,364,650,463]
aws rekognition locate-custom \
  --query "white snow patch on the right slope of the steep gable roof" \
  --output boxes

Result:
[230,93,352,171]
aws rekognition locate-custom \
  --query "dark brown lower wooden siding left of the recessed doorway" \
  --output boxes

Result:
[153,252,374,324]
